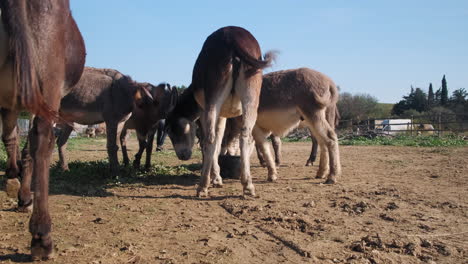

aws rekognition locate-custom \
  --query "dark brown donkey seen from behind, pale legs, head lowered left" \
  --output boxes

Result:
[166,26,272,196]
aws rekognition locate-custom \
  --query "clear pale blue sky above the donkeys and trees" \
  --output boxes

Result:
[70,0,468,103]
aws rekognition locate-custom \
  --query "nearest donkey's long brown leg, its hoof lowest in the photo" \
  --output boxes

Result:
[29,117,54,259]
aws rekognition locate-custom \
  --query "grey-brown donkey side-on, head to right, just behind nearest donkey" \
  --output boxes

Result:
[53,67,154,176]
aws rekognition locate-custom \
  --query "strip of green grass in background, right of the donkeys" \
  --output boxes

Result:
[340,135,468,147]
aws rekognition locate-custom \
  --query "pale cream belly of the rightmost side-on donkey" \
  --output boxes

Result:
[255,108,301,136]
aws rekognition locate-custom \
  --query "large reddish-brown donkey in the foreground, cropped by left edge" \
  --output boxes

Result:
[0,0,85,259]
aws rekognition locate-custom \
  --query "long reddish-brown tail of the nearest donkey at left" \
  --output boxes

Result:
[1,0,57,121]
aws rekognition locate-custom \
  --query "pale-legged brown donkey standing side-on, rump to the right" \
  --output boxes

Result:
[223,68,341,184]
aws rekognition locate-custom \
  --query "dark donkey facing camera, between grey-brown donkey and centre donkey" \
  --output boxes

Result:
[120,83,178,169]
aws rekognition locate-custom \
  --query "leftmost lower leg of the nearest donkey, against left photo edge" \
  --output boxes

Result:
[1,109,20,198]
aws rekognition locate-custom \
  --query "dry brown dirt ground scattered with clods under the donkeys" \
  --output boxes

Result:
[0,137,468,263]
